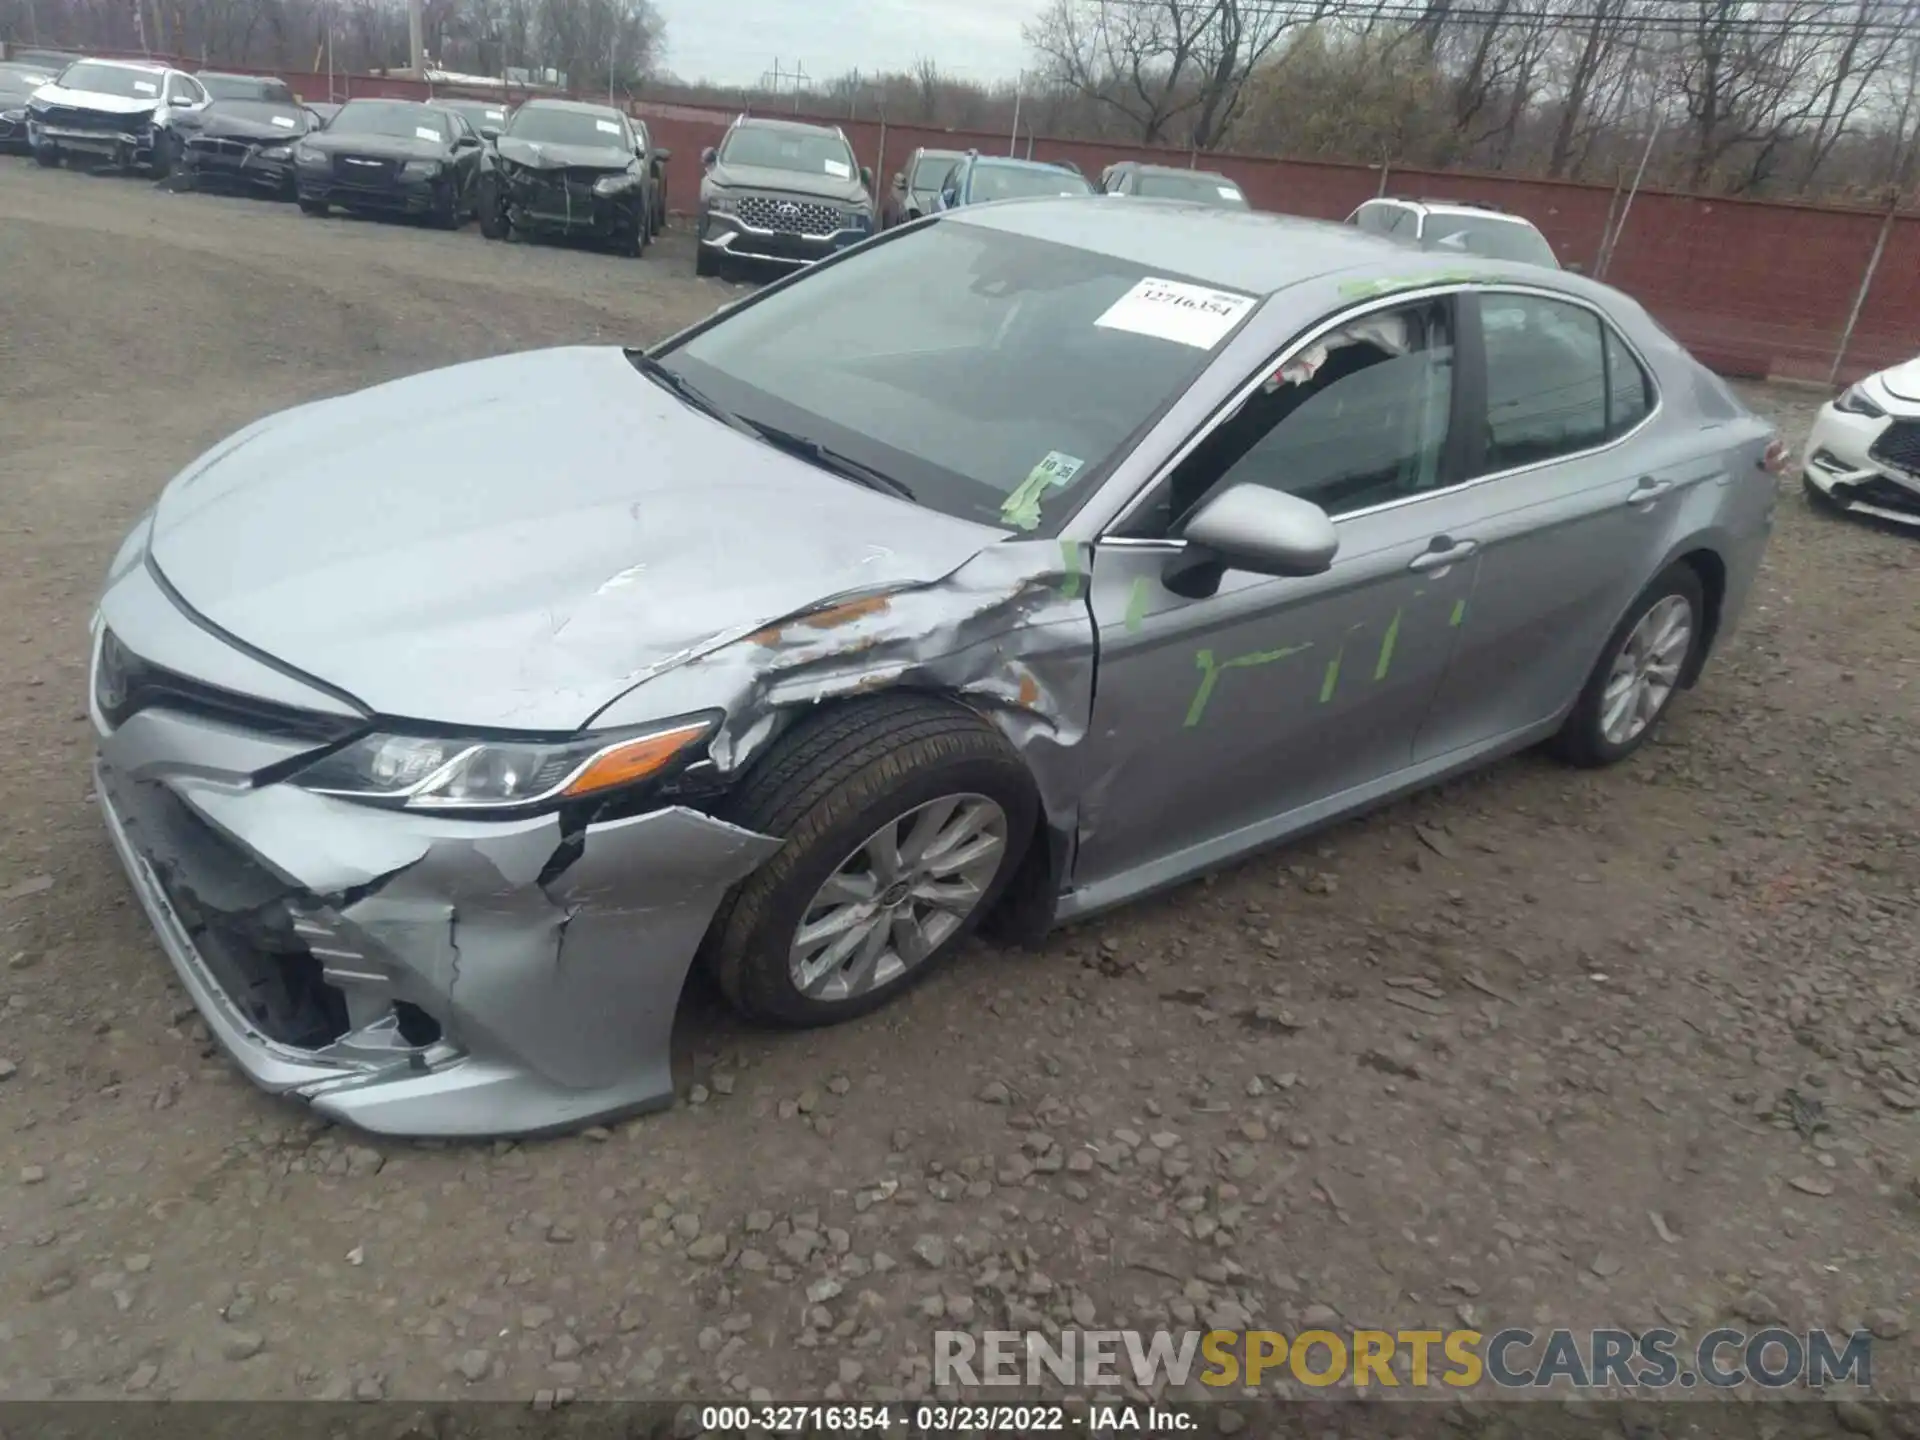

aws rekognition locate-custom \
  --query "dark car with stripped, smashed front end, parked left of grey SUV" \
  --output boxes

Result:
[478,100,653,255]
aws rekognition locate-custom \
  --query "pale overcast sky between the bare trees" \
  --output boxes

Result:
[653,0,1043,84]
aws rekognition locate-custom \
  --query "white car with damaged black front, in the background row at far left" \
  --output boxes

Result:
[27,60,207,177]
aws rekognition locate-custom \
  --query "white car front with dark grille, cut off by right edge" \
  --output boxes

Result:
[1803,359,1920,526]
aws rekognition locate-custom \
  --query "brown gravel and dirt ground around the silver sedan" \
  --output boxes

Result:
[0,159,1920,1425]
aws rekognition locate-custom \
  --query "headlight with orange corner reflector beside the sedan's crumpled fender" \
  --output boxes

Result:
[294,716,718,810]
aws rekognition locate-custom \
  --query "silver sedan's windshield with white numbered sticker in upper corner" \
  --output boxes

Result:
[662,223,1256,532]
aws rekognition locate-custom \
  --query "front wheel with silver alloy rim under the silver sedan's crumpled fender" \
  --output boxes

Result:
[707,697,1039,1025]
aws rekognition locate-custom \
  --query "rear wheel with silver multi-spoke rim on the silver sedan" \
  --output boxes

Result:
[1549,563,1707,768]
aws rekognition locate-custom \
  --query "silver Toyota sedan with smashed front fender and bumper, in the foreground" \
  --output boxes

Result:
[90,200,1786,1135]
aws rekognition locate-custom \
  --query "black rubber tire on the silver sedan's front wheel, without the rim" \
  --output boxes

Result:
[703,695,1039,1027]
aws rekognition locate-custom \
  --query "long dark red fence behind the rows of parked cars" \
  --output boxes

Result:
[33,54,1920,380]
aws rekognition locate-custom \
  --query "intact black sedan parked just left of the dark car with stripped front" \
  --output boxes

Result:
[294,100,486,230]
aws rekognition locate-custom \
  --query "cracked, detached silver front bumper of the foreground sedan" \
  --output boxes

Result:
[90,595,780,1137]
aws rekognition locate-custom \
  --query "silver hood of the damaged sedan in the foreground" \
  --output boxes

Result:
[152,348,1000,732]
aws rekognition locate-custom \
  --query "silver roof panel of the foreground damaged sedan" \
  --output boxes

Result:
[943,196,1548,296]
